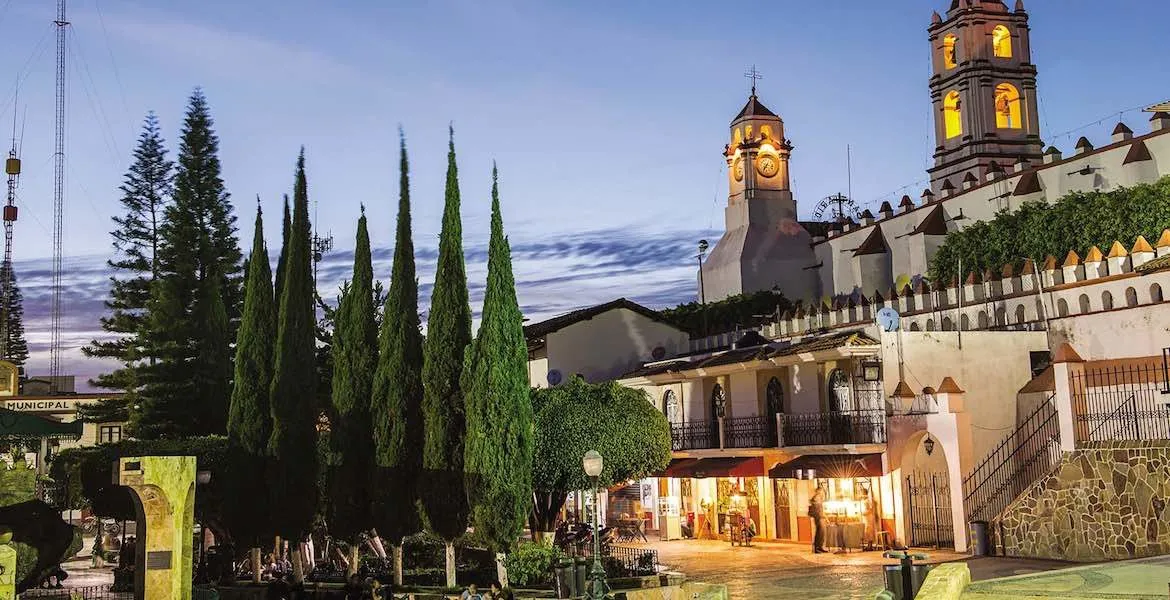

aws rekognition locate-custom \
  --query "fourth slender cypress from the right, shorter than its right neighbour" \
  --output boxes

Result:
[328,207,378,574]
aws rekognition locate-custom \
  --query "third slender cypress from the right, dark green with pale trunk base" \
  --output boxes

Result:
[372,131,422,580]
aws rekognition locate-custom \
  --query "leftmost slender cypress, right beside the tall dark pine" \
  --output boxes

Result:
[227,206,276,456]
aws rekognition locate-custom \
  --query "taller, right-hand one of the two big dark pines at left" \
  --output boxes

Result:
[130,89,242,439]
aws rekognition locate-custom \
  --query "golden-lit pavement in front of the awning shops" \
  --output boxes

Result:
[649,540,1069,600]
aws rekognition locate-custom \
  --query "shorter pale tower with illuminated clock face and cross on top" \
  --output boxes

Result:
[698,69,815,302]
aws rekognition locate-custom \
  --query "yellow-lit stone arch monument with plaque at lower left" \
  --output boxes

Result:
[116,456,195,600]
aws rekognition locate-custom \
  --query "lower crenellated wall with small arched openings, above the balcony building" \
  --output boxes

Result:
[690,229,1170,358]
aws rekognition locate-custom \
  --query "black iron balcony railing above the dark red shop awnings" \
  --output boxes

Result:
[670,409,886,451]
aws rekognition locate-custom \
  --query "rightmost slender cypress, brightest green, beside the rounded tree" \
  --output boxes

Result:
[462,166,534,574]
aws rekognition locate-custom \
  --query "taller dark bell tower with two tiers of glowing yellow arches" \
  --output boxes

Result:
[928,0,1042,193]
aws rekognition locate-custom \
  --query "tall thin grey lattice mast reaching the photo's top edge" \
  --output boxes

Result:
[49,0,69,383]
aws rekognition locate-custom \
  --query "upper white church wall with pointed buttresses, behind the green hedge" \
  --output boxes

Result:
[805,112,1170,299]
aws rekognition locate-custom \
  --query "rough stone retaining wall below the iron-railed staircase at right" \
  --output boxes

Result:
[992,441,1170,561]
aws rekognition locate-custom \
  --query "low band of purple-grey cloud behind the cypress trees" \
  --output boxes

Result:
[15,224,715,388]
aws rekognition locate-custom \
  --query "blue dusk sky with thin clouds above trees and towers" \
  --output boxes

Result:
[0,0,1170,380]
